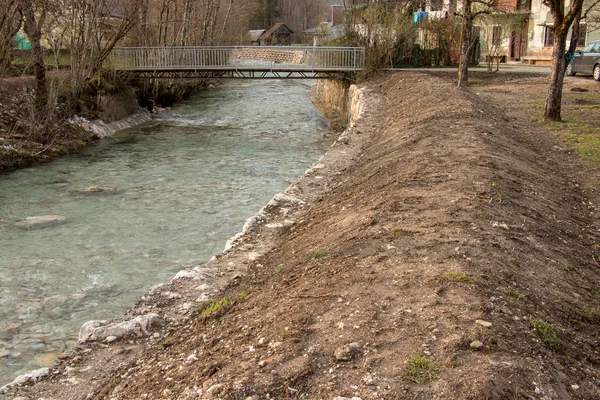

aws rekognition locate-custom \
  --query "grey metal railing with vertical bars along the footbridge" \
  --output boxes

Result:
[107,46,365,71]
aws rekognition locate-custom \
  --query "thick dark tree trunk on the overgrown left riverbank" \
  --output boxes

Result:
[21,0,48,117]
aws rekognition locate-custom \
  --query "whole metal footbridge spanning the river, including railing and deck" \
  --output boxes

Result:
[106,46,365,79]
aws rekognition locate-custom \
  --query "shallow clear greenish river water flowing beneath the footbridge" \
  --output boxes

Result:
[0,80,333,386]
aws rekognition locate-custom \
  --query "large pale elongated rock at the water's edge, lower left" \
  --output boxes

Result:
[78,314,165,343]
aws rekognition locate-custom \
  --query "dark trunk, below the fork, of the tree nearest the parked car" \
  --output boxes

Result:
[544,29,567,121]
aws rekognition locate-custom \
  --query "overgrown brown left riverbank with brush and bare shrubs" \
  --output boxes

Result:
[0,76,216,173]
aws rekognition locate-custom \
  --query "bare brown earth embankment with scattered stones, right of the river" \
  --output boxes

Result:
[5,71,600,399]
